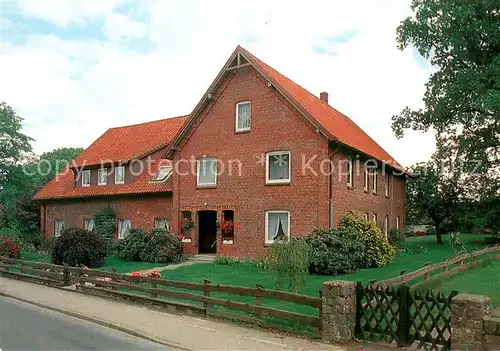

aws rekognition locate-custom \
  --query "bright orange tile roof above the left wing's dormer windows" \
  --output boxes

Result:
[72,116,187,167]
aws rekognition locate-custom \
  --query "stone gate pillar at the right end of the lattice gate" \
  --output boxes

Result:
[451,294,490,351]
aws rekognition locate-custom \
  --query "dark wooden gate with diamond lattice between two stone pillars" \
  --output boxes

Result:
[356,283,458,351]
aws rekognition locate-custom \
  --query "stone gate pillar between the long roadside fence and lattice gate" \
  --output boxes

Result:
[322,280,357,344]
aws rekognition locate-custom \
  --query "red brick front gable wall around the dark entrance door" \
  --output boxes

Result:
[173,67,328,257]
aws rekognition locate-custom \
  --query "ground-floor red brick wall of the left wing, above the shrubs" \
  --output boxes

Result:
[41,196,172,238]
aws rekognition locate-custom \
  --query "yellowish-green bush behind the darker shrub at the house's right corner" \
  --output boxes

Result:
[339,213,396,268]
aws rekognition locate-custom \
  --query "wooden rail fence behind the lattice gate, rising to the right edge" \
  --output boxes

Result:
[372,245,500,289]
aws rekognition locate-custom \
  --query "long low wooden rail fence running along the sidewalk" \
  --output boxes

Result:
[0,257,322,336]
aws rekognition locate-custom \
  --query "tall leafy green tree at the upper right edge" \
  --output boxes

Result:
[392,0,500,181]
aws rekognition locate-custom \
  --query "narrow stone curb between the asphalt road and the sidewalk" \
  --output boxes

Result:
[0,291,192,351]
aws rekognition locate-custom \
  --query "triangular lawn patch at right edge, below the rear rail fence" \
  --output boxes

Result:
[427,261,500,307]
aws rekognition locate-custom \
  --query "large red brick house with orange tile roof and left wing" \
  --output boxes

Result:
[35,46,406,257]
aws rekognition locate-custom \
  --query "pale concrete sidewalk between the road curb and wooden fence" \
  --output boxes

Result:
[0,277,347,351]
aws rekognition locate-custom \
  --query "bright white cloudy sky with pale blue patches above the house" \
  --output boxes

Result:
[0,0,435,166]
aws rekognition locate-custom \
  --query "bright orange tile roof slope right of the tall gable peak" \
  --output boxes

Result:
[235,46,405,171]
